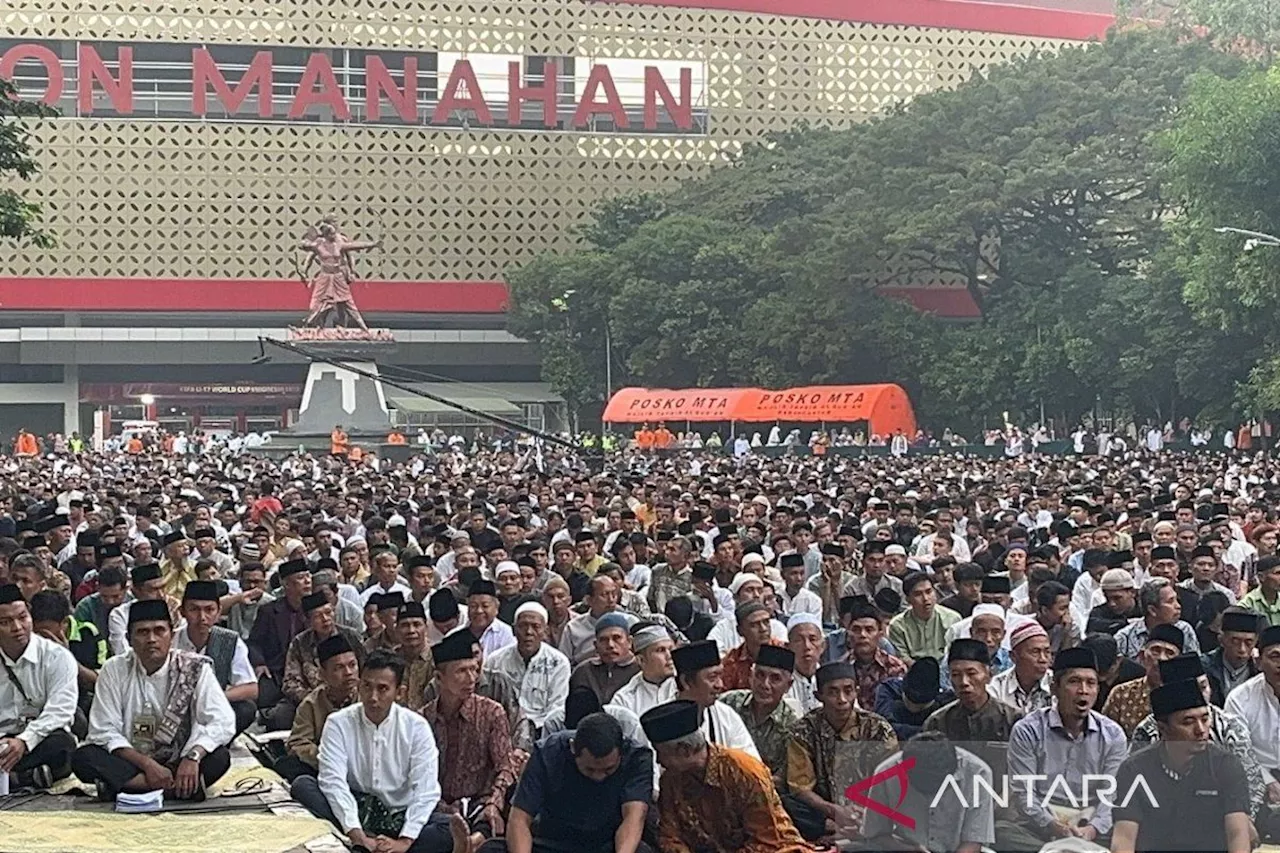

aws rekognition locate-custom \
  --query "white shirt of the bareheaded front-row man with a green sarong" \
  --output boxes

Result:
[319,702,440,838]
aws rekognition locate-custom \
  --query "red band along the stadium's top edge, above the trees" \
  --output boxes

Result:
[596,0,1115,41]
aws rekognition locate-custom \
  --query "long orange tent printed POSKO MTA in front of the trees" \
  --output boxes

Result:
[604,384,915,435]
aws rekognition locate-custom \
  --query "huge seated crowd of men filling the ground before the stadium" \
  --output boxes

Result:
[0,425,1280,853]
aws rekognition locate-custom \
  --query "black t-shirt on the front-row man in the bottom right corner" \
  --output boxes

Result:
[1112,743,1249,853]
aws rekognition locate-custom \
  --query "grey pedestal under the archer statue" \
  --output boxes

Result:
[284,329,396,442]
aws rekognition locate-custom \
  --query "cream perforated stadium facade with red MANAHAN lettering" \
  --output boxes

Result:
[0,0,1112,435]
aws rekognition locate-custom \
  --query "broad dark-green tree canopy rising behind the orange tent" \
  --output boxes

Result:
[509,27,1264,428]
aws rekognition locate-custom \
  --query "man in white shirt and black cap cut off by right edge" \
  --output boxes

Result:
[1224,625,1280,838]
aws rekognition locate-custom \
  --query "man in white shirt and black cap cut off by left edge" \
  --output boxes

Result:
[0,584,79,788]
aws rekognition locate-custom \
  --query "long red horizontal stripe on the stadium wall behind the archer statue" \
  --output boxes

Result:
[0,278,508,316]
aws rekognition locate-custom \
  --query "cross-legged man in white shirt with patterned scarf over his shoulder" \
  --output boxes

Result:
[72,601,236,800]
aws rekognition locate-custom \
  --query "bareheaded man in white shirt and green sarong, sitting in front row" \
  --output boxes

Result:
[291,651,452,853]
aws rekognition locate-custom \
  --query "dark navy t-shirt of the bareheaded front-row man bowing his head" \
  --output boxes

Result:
[511,731,653,850]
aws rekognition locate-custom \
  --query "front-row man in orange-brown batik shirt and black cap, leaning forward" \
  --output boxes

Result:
[640,699,823,853]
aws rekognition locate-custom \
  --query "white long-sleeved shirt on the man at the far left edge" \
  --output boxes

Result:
[0,634,79,752]
